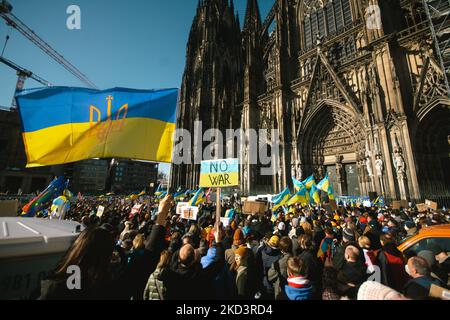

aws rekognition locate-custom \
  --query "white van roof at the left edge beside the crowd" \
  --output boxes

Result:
[0,217,83,259]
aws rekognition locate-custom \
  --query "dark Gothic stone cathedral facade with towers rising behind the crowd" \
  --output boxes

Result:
[171,0,450,200]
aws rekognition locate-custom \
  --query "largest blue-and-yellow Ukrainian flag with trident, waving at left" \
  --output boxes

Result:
[16,87,178,167]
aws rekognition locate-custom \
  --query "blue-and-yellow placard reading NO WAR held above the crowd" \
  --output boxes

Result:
[200,159,239,188]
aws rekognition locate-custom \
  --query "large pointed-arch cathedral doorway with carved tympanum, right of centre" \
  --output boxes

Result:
[300,101,367,195]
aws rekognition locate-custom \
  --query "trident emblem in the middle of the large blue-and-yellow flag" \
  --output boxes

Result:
[89,96,128,141]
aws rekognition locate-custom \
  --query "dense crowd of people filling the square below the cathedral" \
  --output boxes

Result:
[36,195,450,300]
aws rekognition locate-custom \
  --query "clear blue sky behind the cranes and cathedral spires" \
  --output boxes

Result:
[0,0,273,172]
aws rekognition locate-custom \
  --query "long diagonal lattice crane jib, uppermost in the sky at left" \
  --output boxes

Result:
[0,0,98,89]
